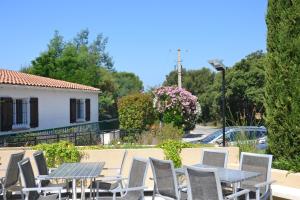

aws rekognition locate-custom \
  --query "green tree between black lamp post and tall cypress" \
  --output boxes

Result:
[225,51,265,125]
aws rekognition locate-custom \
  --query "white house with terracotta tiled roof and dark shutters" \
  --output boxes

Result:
[0,69,100,135]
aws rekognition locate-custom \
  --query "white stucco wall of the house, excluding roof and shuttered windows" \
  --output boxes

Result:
[0,84,98,134]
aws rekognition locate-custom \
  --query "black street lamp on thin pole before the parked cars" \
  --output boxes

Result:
[208,59,226,147]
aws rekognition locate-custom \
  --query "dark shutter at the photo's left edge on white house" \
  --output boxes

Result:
[0,97,13,131]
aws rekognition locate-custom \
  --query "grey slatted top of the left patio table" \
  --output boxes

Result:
[49,162,105,179]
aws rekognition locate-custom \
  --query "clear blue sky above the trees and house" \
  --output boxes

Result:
[0,0,267,88]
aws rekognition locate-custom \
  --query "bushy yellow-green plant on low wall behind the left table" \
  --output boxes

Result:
[33,141,82,167]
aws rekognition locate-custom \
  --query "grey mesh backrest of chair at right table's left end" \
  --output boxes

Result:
[150,158,179,199]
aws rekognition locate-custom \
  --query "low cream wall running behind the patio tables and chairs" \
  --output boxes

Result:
[0,147,300,199]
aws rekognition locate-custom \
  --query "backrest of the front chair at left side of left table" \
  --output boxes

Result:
[18,158,40,200]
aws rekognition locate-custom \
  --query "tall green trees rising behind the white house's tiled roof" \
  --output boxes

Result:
[21,29,143,120]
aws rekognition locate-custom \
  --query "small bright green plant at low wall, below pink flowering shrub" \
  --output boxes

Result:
[159,140,192,168]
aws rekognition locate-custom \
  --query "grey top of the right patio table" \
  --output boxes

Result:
[176,164,261,183]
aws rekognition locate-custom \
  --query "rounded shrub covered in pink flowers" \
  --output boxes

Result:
[153,86,201,130]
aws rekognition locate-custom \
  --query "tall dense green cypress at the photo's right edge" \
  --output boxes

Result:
[265,0,300,159]
